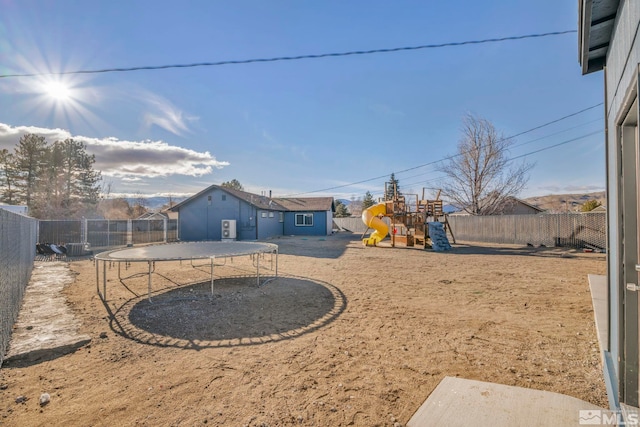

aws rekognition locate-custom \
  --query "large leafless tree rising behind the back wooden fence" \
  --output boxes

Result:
[438,114,533,215]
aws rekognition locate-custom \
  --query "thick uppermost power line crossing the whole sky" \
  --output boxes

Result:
[0,30,577,78]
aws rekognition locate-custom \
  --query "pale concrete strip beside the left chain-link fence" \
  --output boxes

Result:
[2,261,91,366]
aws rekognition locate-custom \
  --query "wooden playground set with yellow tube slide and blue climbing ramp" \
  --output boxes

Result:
[362,182,456,250]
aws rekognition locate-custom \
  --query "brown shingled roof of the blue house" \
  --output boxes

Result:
[170,184,335,212]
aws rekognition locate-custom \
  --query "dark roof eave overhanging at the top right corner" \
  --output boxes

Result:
[578,0,620,74]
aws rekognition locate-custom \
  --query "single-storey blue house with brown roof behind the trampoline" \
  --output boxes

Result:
[171,185,335,241]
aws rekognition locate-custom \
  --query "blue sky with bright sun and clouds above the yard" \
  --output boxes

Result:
[0,0,605,203]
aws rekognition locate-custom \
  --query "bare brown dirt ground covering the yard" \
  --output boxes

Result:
[0,233,608,426]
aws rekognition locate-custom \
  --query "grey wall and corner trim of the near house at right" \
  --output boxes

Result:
[605,1,640,390]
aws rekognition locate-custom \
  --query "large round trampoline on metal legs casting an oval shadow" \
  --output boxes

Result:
[94,241,278,302]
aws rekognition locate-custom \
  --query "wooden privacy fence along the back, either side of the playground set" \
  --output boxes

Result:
[334,212,607,249]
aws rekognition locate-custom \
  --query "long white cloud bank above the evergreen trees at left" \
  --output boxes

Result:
[0,123,229,181]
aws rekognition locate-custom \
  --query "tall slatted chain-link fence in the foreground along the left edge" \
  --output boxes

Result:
[0,209,38,365]
